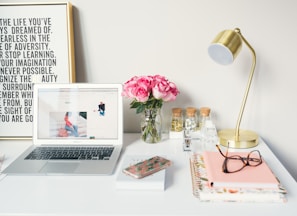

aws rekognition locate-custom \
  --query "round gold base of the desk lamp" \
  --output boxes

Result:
[218,129,259,149]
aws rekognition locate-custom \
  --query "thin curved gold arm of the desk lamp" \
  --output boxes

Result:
[235,29,256,141]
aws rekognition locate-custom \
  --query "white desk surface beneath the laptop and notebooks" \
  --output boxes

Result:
[0,134,297,216]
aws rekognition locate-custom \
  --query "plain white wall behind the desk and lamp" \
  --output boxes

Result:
[0,0,297,179]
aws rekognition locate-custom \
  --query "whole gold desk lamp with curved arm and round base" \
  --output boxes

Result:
[208,28,259,148]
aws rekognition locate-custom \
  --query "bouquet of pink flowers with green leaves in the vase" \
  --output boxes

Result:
[122,75,179,113]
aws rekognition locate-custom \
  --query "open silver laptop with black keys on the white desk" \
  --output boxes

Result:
[2,83,123,175]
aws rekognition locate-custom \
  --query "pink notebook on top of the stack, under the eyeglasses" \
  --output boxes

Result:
[203,151,279,189]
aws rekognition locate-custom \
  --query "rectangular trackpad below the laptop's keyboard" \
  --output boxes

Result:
[40,161,80,173]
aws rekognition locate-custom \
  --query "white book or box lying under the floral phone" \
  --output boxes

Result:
[116,155,166,191]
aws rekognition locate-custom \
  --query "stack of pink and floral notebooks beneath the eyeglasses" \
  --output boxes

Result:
[190,152,286,202]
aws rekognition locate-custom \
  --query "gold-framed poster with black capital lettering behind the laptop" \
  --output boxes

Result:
[0,2,75,139]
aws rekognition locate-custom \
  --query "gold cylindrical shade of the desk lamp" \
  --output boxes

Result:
[208,30,242,65]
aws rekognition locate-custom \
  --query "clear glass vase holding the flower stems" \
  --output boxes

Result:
[141,108,162,143]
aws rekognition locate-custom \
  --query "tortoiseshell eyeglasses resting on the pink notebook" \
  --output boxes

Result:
[216,145,262,173]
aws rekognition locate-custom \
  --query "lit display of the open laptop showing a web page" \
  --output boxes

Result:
[35,84,121,140]
